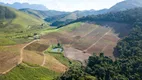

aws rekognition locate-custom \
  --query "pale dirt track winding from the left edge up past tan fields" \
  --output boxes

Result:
[0,40,37,74]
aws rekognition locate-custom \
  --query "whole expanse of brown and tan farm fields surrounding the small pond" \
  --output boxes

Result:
[0,22,129,76]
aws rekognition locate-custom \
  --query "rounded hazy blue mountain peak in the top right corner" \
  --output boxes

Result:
[108,0,142,12]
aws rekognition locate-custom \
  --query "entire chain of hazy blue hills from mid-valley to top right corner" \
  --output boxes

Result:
[45,0,142,26]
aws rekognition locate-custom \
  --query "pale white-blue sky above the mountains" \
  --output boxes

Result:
[0,0,123,11]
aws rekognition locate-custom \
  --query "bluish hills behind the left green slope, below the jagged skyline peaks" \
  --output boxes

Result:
[19,8,68,19]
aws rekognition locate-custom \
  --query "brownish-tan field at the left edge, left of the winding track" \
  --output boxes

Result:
[0,44,24,74]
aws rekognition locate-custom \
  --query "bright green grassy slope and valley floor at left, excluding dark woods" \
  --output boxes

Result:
[0,6,49,45]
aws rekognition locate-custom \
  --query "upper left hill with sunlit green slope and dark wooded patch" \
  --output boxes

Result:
[0,6,44,28]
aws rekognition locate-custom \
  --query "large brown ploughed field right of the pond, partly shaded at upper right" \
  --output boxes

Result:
[42,22,130,62]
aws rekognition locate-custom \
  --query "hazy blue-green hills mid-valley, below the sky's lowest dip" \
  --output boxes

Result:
[45,9,107,26]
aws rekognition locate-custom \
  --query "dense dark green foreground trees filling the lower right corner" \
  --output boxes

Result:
[57,27,142,80]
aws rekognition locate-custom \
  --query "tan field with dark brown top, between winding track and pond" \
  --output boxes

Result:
[23,39,67,72]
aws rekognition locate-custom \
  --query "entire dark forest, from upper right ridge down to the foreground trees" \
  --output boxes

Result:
[57,8,142,80]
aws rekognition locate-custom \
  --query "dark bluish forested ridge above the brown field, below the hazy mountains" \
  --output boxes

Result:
[76,8,142,24]
